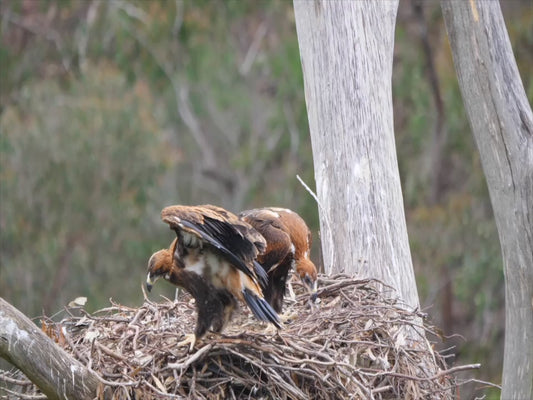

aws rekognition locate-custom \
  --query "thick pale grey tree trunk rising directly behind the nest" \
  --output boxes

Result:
[294,0,419,307]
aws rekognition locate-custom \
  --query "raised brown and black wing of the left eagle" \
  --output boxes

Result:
[161,205,267,286]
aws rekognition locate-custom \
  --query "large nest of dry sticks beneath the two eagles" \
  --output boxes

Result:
[1,275,482,399]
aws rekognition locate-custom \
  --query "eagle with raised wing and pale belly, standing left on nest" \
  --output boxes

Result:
[146,205,281,351]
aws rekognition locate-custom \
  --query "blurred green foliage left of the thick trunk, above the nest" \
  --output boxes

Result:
[0,1,317,314]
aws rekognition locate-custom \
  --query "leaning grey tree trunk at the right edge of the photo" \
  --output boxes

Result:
[441,0,533,399]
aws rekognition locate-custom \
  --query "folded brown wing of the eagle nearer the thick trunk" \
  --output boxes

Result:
[239,208,294,273]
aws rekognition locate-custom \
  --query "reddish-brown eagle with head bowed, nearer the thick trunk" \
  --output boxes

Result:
[239,207,317,313]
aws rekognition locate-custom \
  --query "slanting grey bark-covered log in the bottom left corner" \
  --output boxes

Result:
[0,297,99,400]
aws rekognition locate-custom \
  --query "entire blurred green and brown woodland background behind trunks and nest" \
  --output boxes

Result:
[0,0,533,398]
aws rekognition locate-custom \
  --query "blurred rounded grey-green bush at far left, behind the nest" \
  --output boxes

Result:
[0,64,177,312]
